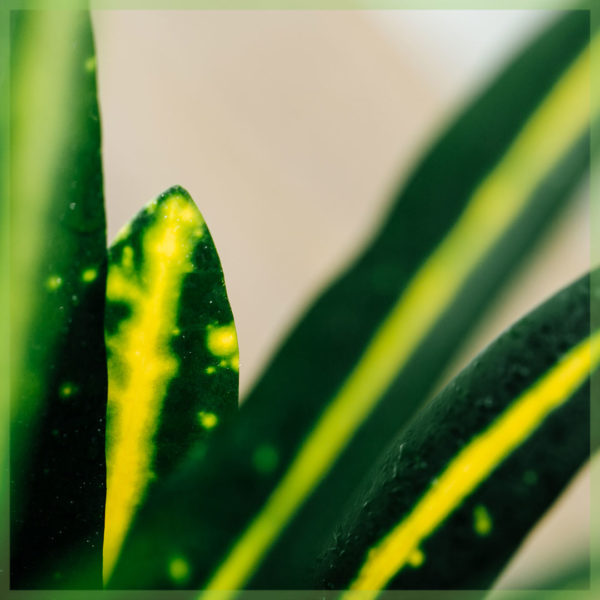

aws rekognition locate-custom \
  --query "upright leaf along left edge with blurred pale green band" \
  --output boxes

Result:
[10,10,107,588]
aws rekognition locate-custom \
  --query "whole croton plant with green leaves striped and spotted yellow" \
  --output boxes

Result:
[9,10,600,600]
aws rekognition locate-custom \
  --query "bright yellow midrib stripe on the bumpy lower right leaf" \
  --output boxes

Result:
[342,332,600,600]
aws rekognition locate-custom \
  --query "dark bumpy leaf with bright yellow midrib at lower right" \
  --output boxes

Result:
[315,276,600,599]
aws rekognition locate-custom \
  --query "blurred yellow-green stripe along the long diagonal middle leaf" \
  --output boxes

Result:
[200,41,590,600]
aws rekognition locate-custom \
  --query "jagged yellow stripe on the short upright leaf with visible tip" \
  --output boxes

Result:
[103,195,204,583]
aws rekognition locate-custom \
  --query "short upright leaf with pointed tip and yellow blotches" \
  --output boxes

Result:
[104,187,238,579]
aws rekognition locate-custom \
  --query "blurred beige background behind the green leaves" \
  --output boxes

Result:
[93,10,590,588]
